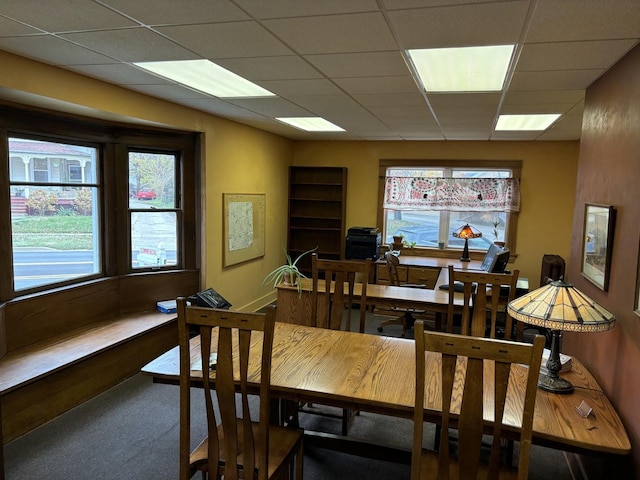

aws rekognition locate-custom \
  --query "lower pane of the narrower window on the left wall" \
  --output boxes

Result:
[131,211,178,268]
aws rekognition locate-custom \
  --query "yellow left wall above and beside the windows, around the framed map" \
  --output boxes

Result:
[0,51,293,310]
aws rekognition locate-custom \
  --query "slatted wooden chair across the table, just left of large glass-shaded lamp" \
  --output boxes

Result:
[447,265,520,340]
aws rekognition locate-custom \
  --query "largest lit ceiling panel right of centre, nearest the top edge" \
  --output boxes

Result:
[407,45,514,92]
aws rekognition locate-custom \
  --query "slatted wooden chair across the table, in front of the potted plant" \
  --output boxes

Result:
[299,253,371,435]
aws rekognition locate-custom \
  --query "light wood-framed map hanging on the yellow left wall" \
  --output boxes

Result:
[222,193,265,267]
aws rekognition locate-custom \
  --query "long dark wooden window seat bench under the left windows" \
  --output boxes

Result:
[0,274,198,443]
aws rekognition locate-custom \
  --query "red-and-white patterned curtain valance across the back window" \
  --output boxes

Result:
[384,177,520,212]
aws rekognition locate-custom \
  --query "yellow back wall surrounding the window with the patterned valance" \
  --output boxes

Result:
[294,142,579,288]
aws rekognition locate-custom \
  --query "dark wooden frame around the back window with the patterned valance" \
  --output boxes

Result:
[376,159,522,260]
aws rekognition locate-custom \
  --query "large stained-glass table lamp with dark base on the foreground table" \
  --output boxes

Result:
[507,280,616,393]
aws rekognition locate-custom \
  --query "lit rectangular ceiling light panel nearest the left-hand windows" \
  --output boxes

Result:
[136,60,275,98]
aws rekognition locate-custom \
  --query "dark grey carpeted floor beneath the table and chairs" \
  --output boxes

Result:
[5,318,572,480]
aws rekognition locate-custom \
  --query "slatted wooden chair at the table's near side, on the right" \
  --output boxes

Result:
[411,322,544,480]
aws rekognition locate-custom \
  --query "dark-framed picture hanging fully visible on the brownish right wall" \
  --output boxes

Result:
[581,203,615,291]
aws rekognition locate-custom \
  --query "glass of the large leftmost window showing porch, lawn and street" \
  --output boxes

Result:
[9,138,102,291]
